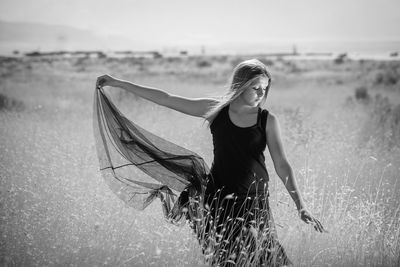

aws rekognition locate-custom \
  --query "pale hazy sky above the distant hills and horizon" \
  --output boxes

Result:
[0,0,400,52]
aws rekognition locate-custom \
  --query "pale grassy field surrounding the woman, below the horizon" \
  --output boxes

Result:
[0,56,400,266]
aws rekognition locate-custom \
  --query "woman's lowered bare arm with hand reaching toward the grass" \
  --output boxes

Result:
[266,113,325,232]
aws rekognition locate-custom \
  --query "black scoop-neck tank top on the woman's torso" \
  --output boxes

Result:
[206,105,269,197]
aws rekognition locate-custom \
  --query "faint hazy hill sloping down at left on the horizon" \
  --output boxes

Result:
[0,21,138,54]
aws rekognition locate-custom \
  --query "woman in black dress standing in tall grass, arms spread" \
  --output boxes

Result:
[97,59,324,266]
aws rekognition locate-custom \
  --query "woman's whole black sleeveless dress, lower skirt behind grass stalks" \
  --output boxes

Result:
[204,106,290,266]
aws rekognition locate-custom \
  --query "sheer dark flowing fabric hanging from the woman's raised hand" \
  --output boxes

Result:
[93,88,209,222]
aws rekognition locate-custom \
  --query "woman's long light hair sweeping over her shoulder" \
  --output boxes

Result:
[205,59,271,125]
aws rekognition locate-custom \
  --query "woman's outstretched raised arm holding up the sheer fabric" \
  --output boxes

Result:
[96,75,217,117]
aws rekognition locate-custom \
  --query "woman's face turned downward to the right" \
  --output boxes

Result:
[240,76,268,107]
